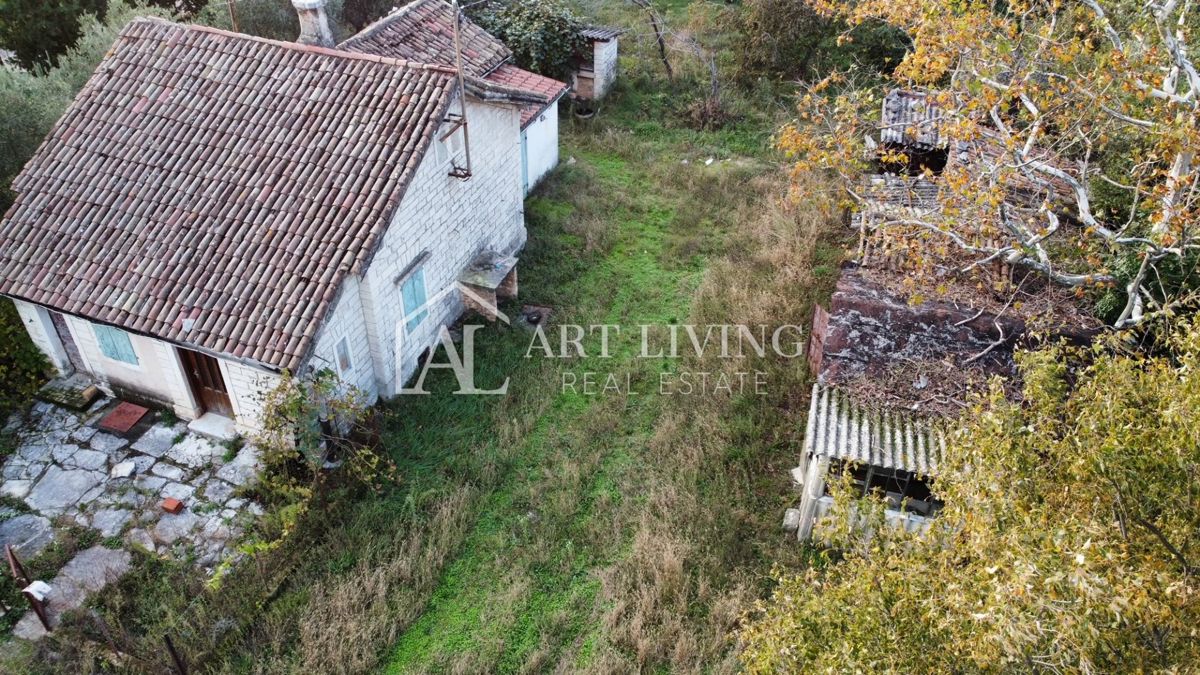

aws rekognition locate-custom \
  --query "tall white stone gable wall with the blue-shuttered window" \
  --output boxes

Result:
[359,91,526,396]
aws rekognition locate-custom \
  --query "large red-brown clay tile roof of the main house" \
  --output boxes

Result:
[0,19,454,369]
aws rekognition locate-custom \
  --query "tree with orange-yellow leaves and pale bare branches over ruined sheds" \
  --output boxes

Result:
[779,0,1200,327]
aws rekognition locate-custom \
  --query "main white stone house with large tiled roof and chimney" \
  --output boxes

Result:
[0,0,550,431]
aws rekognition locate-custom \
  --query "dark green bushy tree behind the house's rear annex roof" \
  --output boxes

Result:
[474,0,584,79]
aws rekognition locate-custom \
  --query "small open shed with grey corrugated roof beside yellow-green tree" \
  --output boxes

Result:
[792,383,946,539]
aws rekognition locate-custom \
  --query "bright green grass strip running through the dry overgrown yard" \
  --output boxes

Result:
[389,138,720,673]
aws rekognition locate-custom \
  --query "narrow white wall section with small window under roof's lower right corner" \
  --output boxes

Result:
[307,276,379,401]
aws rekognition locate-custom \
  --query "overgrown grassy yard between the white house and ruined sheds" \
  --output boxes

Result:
[0,1,854,673]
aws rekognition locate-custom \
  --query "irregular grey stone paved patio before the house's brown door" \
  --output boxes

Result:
[0,400,260,569]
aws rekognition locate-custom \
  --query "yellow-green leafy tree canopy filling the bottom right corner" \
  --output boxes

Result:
[742,323,1200,673]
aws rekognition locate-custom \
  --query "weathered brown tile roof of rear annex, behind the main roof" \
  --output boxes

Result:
[337,0,512,77]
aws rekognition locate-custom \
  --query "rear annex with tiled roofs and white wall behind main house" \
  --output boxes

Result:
[337,0,568,193]
